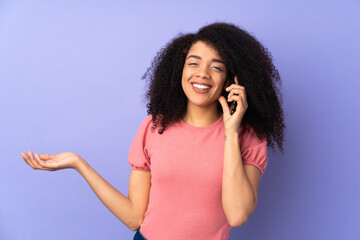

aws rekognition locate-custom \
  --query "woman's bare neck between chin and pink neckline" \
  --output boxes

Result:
[182,103,222,127]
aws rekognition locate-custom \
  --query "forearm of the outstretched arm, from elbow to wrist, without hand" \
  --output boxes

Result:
[76,160,139,230]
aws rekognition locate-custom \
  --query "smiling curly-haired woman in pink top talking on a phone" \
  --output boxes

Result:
[21,23,285,240]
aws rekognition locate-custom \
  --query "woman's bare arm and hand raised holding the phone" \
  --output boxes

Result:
[218,76,261,227]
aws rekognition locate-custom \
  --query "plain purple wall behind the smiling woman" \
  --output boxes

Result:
[0,0,360,240]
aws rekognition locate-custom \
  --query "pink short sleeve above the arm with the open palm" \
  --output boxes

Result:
[128,115,152,171]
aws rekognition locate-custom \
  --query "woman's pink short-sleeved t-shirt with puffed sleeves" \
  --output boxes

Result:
[128,115,267,240]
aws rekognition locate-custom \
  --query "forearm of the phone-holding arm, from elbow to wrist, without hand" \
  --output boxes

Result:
[222,132,256,226]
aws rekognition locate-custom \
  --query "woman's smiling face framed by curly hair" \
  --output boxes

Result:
[181,41,227,111]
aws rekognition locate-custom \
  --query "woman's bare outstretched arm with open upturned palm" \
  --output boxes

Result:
[21,152,151,231]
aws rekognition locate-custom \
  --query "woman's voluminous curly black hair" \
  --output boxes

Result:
[142,22,285,153]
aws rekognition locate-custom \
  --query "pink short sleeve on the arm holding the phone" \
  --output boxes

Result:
[239,127,268,176]
